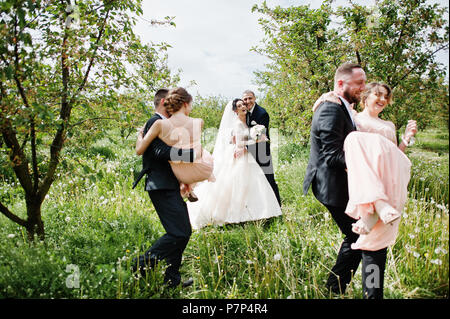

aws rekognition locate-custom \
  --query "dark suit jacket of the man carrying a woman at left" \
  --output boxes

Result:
[133,114,194,191]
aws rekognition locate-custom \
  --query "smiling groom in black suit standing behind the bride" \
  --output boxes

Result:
[242,90,281,206]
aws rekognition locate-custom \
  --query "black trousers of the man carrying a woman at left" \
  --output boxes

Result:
[140,190,192,285]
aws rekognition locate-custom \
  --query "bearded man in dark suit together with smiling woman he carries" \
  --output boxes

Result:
[303,63,417,299]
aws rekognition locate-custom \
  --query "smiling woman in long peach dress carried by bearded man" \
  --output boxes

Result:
[344,83,417,251]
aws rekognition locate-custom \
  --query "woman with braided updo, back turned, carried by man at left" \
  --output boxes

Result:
[136,88,215,201]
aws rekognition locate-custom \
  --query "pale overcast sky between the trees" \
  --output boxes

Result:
[135,0,448,98]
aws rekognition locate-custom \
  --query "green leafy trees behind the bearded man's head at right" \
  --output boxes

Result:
[253,0,449,144]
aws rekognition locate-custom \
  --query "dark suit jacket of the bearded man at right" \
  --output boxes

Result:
[303,100,356,207]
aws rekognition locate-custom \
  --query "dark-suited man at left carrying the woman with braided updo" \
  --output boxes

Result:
[132,89,195,287]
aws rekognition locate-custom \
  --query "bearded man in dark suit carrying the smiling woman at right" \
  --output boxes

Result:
[303,63,366,293]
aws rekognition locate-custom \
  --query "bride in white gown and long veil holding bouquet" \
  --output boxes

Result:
[187,99,281,229]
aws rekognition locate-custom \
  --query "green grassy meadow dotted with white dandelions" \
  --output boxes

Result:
[0,126,449,298]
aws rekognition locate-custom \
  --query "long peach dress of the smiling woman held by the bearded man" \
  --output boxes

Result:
[344,113,411,251]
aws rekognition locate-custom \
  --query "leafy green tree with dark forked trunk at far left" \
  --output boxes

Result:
[0,0,177,239]
